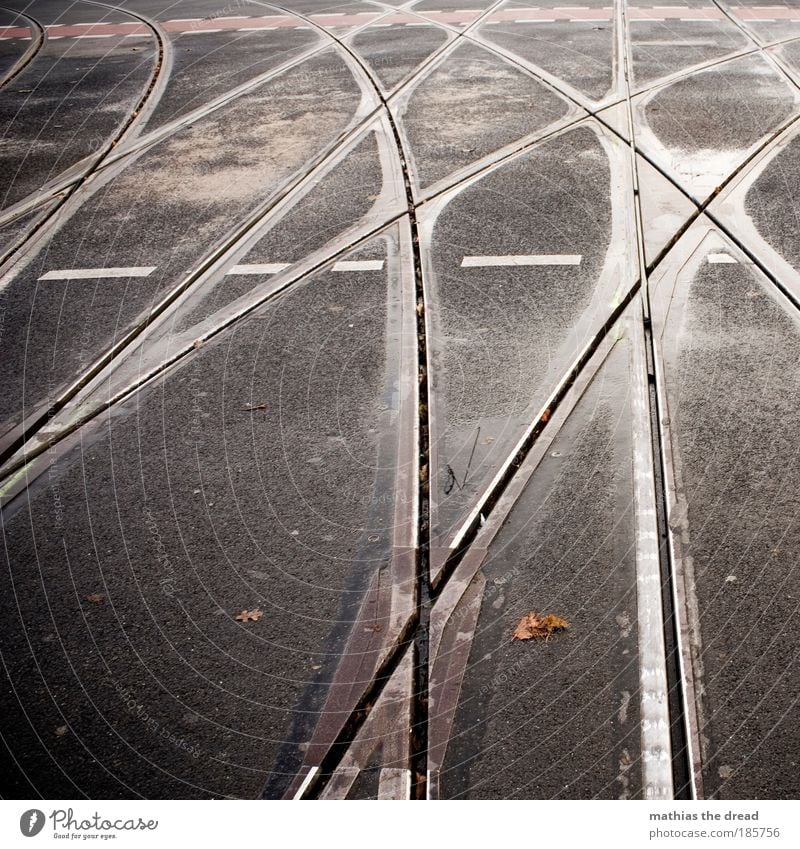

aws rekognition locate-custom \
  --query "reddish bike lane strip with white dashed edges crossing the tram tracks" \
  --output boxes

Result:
[7,6,800,40]
